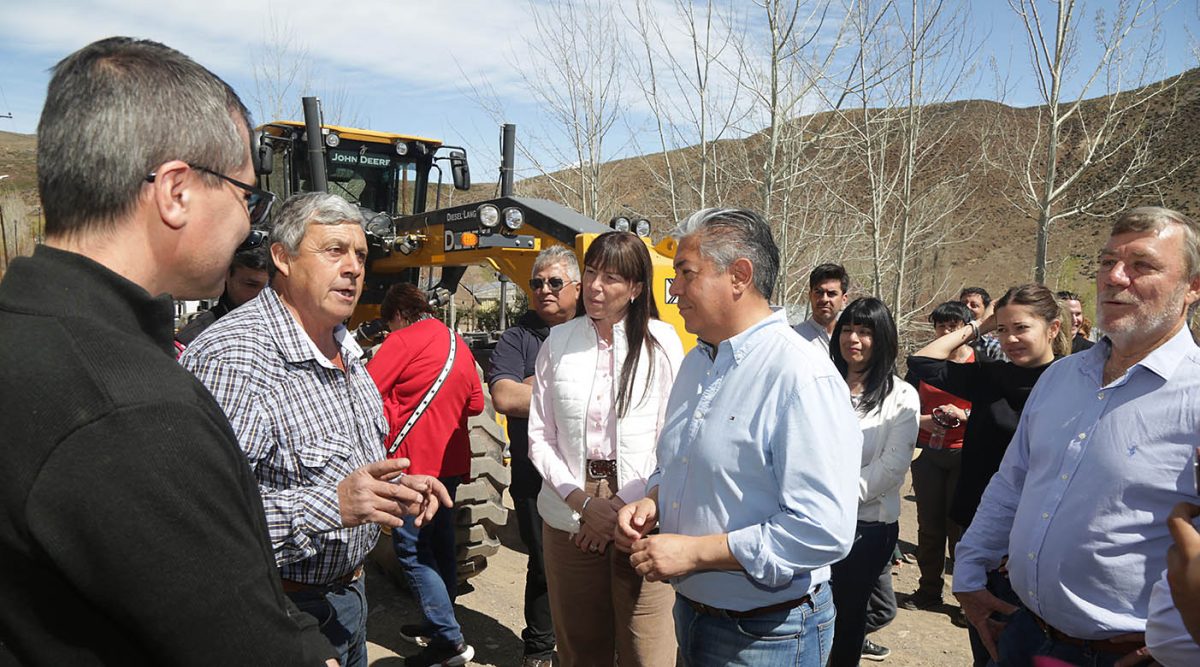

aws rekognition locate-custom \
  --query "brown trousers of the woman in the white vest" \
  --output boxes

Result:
[542,477,676,667]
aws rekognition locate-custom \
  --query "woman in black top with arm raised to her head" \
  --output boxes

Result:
[908,283,1070,666]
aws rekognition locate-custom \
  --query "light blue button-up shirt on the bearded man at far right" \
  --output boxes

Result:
[954,328,1200,639]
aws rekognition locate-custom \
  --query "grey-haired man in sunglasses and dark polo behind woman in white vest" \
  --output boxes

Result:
[487,246,580,667]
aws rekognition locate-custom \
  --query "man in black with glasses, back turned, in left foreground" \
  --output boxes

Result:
[0,37,343,666]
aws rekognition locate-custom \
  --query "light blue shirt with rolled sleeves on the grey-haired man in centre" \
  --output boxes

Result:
[647,310,863,611]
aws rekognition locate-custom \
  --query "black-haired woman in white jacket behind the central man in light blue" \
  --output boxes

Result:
[829,296,920,667]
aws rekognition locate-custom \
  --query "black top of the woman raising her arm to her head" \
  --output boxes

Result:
[908,356,1050,529]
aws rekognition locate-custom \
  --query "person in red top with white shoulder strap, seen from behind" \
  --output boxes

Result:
[367,283,484,665]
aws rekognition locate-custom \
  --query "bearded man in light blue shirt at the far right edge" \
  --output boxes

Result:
[954,208,1200,665]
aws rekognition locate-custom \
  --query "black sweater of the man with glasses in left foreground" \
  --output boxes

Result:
[0,246,335,666]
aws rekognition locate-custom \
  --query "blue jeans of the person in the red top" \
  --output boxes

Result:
[391,477,463,644]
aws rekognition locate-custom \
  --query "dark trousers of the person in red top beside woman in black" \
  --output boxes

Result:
[912,449,962,597]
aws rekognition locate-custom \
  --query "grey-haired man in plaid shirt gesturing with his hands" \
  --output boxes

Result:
[180,193,450,667]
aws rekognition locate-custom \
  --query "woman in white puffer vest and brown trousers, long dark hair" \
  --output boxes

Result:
[529,232,683,667]
